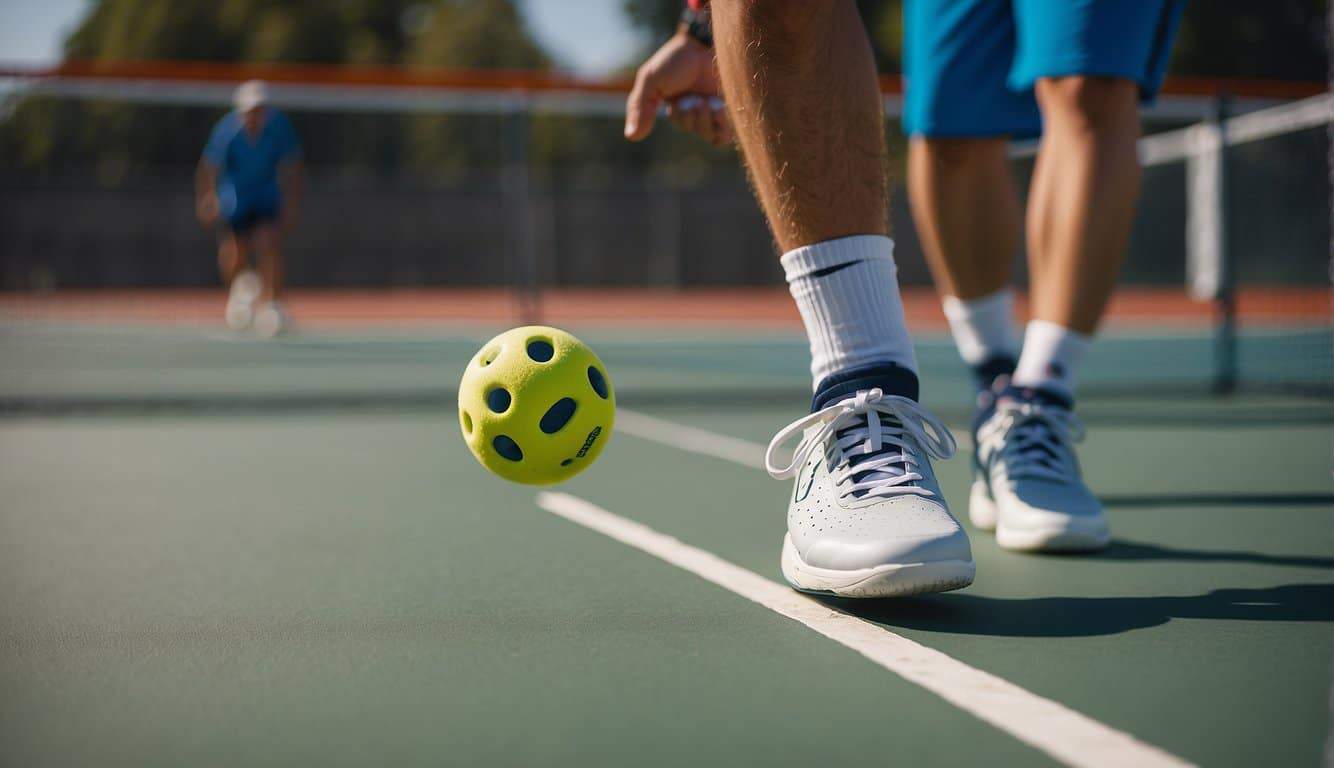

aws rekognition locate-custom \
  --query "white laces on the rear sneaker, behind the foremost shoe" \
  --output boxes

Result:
[978,403,1085,481]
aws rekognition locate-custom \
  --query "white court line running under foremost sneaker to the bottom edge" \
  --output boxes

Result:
[538,492,1190,768]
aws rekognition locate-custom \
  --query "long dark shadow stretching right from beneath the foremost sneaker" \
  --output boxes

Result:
[818,584,1334,637]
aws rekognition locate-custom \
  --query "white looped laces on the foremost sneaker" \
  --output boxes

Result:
[764,389,956,496]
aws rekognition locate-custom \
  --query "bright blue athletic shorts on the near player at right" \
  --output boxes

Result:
[903,0,1185,137]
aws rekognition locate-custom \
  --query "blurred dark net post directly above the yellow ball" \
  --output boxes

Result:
[504,95,542,325]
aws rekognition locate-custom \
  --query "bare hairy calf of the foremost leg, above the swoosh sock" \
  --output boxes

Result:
[712,0,888,252]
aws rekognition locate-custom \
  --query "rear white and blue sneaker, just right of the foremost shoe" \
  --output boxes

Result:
[968,389,1111,552]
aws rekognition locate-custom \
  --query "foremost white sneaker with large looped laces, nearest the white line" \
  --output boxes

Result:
[764,389,976,597]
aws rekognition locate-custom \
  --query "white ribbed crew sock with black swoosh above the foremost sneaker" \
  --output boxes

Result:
[782,235,916,385]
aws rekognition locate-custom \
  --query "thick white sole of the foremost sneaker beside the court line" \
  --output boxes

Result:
[782,536,978,597]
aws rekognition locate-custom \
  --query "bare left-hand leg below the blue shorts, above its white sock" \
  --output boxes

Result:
[908,137,1022,300]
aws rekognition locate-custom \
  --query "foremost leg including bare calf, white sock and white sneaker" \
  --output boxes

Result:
[712,0,975,597]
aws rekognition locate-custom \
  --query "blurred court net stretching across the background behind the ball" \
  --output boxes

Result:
[0,67,1334,412]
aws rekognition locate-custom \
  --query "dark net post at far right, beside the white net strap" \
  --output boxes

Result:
[1210,92,1237,395]
